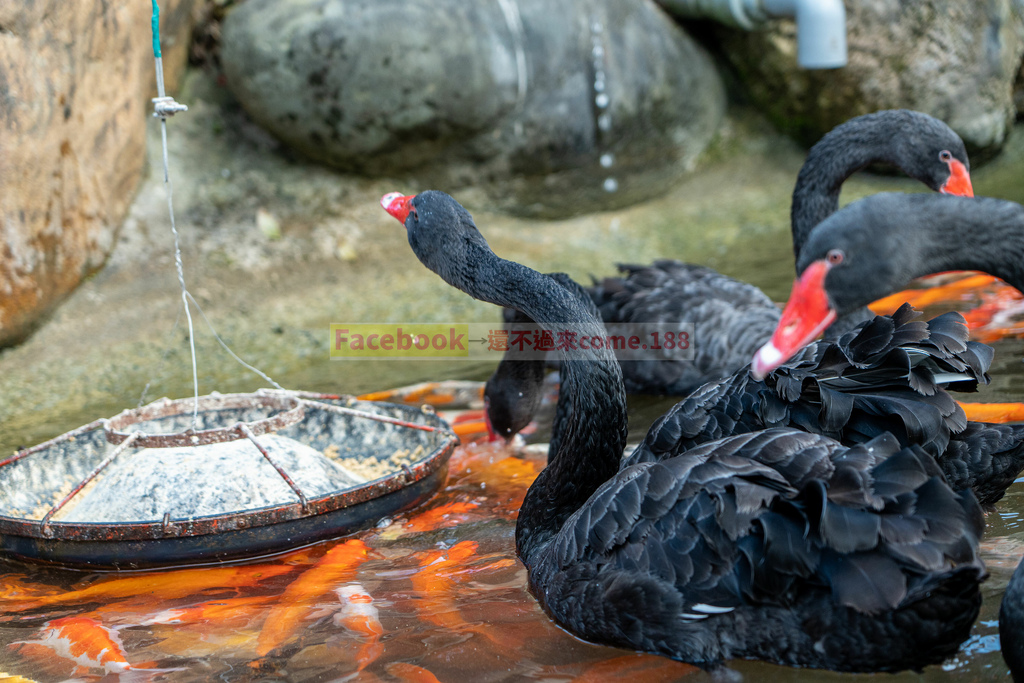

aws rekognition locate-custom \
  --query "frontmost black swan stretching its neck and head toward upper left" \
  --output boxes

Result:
[382,187,984,671]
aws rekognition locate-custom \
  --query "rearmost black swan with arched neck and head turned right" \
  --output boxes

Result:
[590,110,973,395]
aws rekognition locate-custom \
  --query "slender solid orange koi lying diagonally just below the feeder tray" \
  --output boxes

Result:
[252,539,371,667]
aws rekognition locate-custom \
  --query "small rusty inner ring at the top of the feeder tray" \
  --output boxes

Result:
[103,393,305,449]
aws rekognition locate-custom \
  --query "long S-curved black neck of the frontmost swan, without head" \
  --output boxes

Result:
[442,240,627,566]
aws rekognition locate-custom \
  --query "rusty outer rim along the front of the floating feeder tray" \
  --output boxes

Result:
[0,434,459,541]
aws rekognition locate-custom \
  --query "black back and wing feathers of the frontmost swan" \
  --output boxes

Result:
[531,429,984,660]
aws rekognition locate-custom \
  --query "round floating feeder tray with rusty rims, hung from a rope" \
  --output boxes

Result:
[0,390,458,568]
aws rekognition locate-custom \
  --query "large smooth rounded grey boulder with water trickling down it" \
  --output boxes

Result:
[221,0,724,215]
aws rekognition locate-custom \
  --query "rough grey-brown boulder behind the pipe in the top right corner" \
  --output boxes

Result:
[718,0,1024,158]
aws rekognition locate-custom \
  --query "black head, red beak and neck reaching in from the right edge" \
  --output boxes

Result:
[751,193,1024,377]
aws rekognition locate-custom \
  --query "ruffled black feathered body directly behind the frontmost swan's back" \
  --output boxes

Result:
[628,304,1024,505]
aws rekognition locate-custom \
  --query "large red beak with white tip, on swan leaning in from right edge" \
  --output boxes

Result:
[751,259,836,380]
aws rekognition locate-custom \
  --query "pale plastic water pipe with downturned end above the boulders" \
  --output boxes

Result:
[657,0,846,69]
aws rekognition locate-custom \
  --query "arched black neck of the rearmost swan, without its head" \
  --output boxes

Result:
[790,111,929,262]
